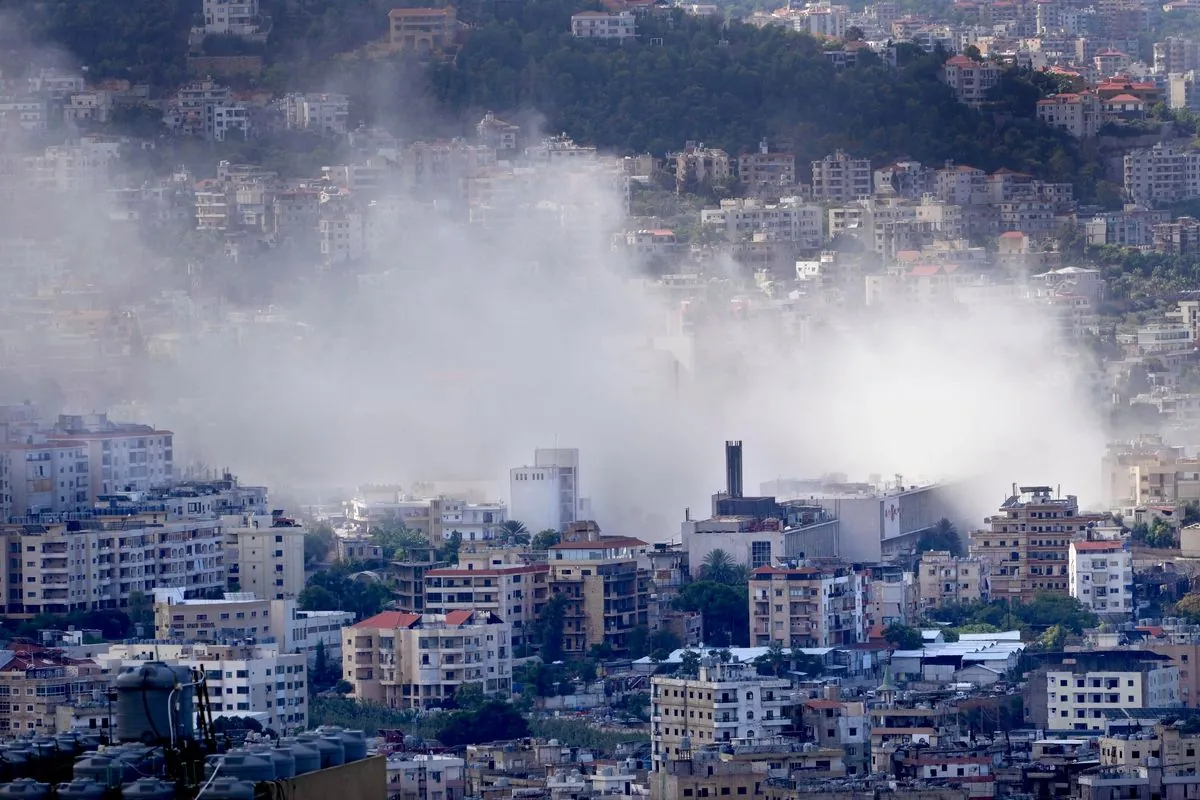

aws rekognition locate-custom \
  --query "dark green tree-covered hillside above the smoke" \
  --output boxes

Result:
[0,0,1103,200]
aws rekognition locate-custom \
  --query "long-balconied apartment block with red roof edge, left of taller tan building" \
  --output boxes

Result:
[425,552,550,648]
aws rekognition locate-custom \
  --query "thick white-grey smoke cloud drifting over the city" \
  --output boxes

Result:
[0,28,1105,540]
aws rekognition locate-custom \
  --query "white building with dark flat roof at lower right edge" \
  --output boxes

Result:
[1045,650,1183,732]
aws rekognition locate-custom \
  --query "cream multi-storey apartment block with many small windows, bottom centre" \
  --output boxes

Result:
[650,656,792,772]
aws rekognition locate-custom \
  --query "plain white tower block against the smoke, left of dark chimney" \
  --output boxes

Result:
[509,447,580,533]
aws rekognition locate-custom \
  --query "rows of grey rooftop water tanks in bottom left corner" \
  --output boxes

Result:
[0,727,367,800]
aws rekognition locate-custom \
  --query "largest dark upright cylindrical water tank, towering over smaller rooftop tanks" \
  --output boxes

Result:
[116,661,196,742]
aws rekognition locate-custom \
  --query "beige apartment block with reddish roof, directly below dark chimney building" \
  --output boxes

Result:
[749,566,868,648]
